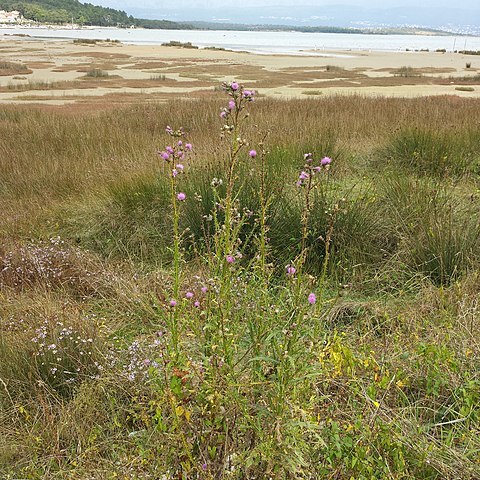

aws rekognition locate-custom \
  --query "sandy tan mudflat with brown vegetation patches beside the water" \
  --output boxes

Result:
[0,37,480,105]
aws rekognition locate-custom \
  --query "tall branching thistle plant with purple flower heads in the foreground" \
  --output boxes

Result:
[152,87,340,478]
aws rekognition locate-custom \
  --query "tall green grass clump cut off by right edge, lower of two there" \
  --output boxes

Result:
[381,175,480,285]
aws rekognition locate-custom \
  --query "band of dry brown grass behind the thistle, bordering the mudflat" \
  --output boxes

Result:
[0,93,480,237]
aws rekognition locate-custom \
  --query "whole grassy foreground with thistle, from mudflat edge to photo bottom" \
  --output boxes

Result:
[0,92,480,479]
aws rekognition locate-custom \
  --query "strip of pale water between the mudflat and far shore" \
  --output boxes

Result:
[0,25,480,56]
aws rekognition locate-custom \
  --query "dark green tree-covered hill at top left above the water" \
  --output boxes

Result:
[0,0,192,30]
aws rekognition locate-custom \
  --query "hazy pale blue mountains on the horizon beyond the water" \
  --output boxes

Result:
[127,0,480,34]
